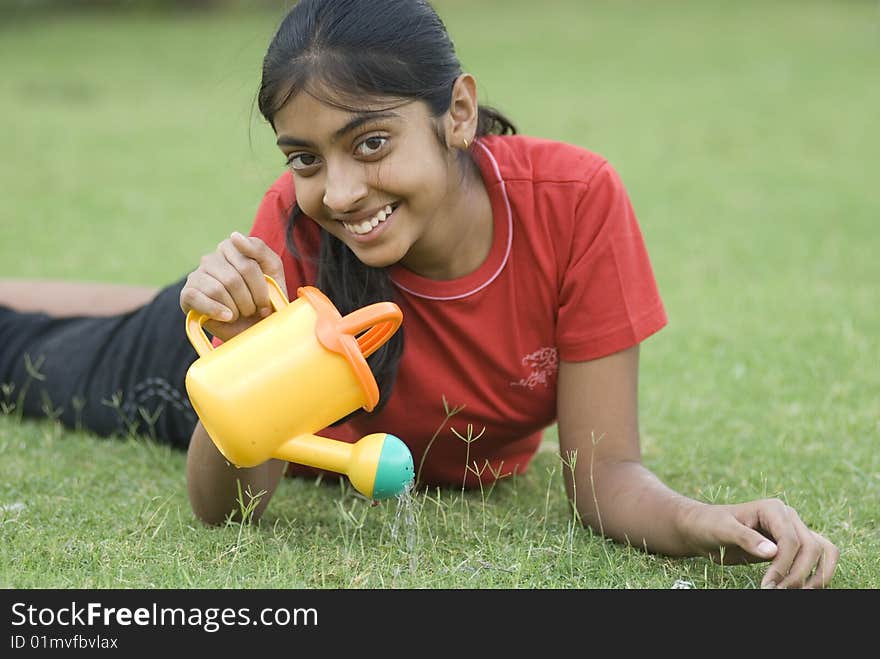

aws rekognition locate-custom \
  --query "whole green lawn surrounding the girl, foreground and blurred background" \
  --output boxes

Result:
[0,0,880,588]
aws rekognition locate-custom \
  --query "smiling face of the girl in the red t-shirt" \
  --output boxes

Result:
[274,93,461,272]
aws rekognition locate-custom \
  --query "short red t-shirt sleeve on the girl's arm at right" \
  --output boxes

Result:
[556,163,667,361]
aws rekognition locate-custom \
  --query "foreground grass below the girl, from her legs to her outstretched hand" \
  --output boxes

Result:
[0,419,772,589]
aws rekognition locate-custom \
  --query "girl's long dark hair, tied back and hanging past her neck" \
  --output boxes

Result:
[258,0,516,422]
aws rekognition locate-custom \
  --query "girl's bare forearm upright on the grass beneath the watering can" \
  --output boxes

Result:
[186,422,286,524]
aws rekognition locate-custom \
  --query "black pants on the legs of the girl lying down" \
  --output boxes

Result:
[0,279,198,448]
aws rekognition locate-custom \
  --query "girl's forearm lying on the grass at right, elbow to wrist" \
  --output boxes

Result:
[567,460,705,556]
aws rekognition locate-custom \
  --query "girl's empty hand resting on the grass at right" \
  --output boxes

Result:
[686,499,840,588]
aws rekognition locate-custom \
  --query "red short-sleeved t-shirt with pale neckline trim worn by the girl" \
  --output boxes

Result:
[244,136,667,485]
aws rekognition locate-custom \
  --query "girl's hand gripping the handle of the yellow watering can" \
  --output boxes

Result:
[180,231,287,341]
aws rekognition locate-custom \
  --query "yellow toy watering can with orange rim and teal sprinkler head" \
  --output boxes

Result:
[186,276,414,499]
